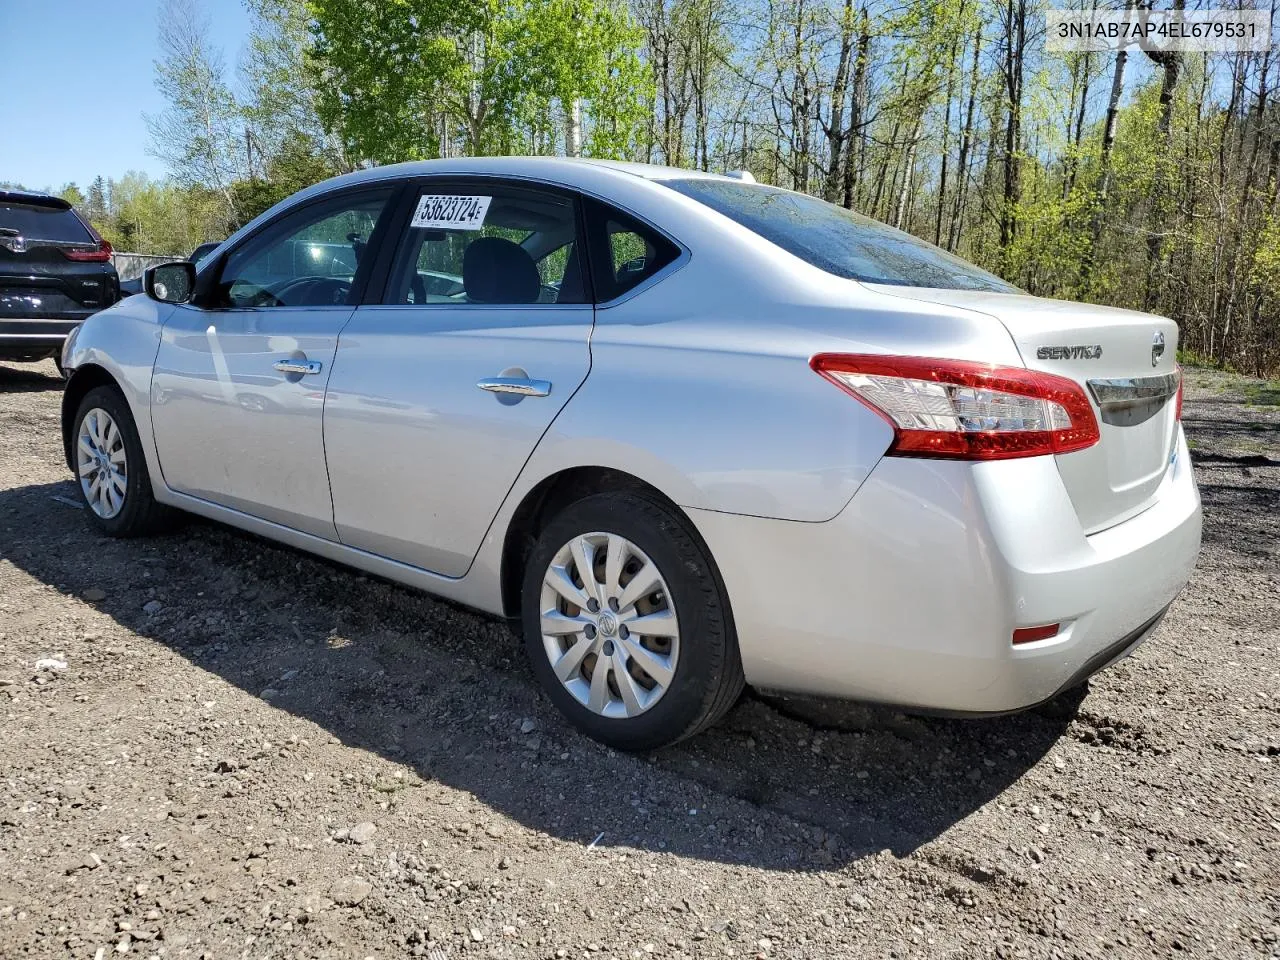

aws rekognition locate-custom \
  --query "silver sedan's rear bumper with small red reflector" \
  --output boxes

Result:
[690,430,1201,713]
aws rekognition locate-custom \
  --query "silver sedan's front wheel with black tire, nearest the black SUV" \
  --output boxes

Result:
[72,387,173,536]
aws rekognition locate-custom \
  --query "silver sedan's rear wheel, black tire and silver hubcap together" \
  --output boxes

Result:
[521,493,744,750]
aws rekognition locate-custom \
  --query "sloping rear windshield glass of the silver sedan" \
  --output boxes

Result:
[663,178,1019,293]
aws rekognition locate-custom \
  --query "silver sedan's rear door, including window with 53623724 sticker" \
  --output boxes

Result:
[324,178,594,576]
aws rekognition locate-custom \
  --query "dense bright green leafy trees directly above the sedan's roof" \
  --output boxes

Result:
[307,0,648,163]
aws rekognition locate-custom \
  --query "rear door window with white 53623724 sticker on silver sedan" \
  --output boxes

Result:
[387,184,586,306]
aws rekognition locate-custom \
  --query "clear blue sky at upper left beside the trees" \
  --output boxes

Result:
[0,0,250,189]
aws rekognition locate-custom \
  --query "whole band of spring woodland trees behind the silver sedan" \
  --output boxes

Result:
[87,0,1280,372]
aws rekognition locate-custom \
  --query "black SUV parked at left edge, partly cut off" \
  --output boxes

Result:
[0,191,120,361]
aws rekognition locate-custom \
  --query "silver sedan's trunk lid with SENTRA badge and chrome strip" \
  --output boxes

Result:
[868,284,1178,534]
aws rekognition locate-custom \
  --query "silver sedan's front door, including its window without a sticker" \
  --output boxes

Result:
[151,187,394,539]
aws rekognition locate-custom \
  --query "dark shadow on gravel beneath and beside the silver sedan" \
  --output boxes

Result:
[0,481,1080,882]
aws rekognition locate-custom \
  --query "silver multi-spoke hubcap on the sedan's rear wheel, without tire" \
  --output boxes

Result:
[540,532,680,718]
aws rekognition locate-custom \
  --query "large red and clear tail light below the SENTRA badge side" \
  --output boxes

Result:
[809,353,1098,460]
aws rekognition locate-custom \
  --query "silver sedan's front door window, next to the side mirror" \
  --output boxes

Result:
[215,191,390,307]
